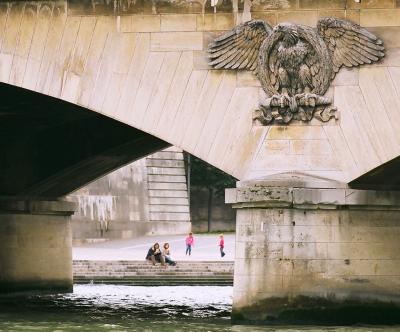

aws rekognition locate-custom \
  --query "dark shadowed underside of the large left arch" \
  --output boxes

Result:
[0,83,169,197]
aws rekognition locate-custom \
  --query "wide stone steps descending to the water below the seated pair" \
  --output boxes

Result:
[73,260,233,286]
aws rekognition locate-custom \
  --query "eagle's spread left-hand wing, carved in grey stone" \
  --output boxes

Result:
[208,20,272,70]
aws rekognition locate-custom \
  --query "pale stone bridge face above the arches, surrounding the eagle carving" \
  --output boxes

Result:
[0,0,400,182]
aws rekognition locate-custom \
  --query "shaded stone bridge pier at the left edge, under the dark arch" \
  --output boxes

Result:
[0,199,75,293]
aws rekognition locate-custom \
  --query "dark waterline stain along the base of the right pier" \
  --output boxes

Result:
[232,296,400,326]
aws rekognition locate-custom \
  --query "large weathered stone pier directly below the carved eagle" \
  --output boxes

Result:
[226,174,400,325]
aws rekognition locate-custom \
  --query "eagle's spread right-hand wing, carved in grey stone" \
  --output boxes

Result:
[317,18,385,75]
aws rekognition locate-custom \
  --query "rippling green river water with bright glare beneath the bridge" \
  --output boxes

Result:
[0,285,400,332]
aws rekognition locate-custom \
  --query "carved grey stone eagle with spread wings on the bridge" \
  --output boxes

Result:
[208,18,385,124]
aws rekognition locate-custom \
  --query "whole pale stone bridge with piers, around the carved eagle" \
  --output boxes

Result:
[0,0,400,326]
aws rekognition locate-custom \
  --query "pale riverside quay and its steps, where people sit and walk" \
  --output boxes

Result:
[73,234,235,285]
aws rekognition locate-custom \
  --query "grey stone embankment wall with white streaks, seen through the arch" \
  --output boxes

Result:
[69,148,191,244]
